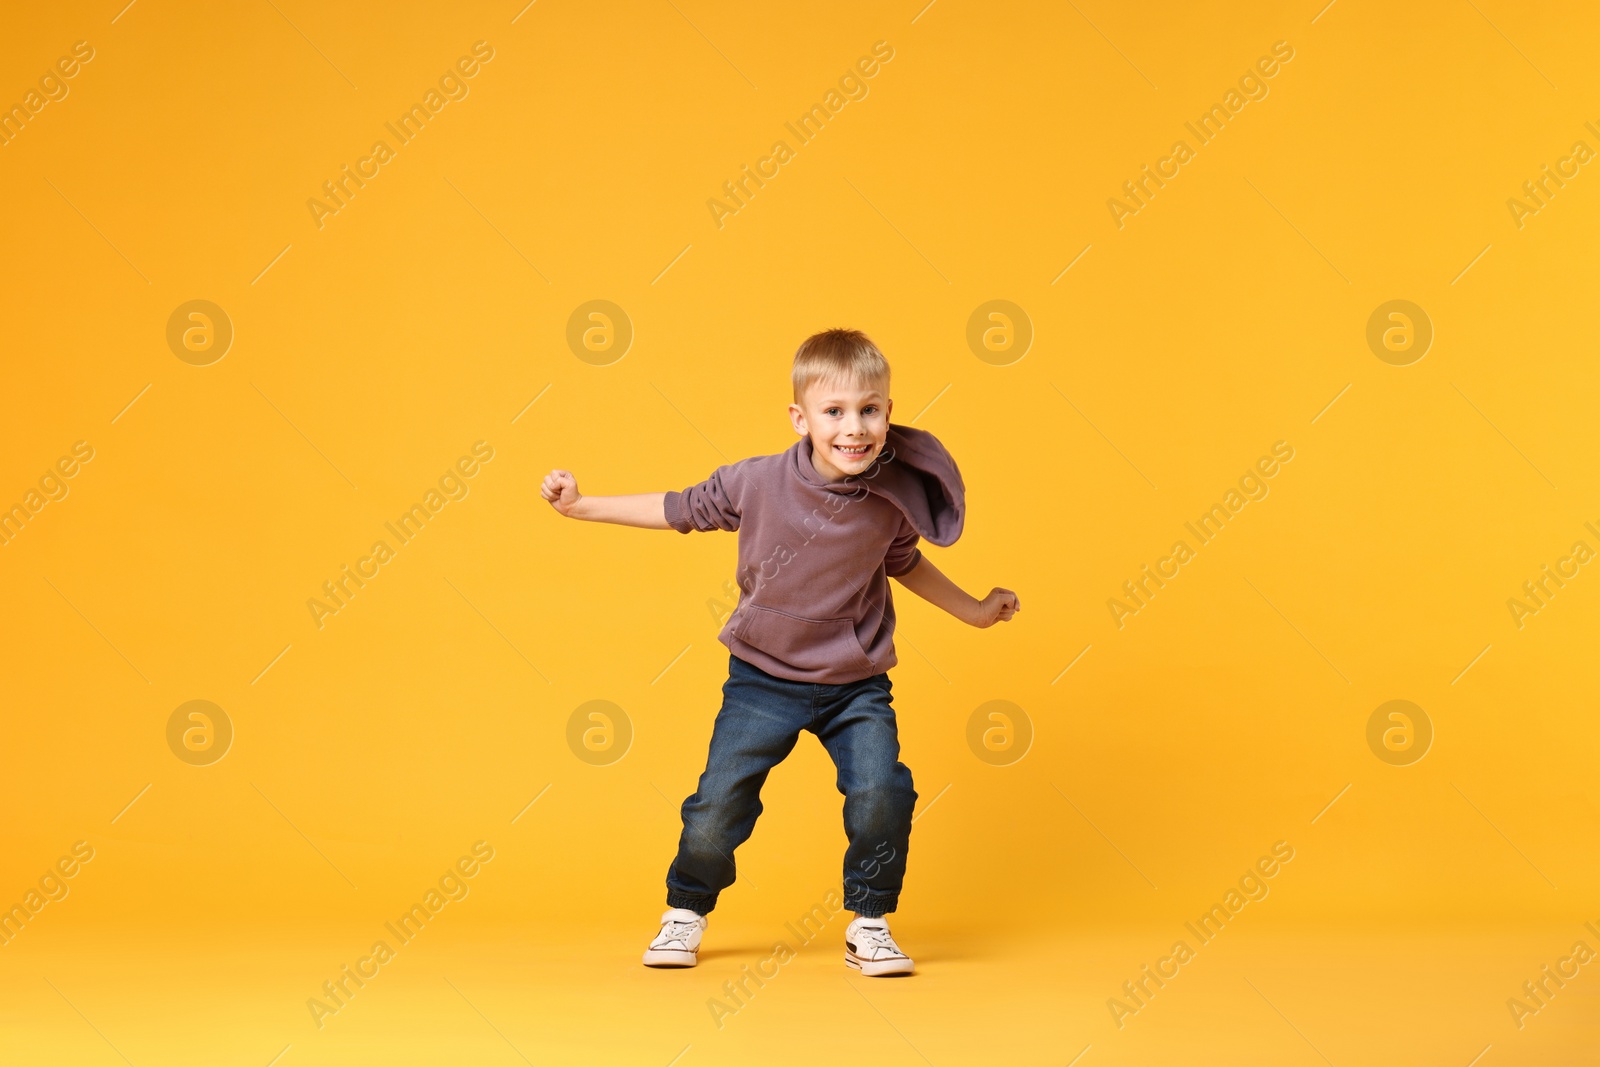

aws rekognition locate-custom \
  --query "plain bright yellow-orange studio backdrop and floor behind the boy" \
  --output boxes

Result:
[0,0,1600,1067]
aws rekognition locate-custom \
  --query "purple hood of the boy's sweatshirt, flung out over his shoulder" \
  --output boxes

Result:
[795,422,966,549]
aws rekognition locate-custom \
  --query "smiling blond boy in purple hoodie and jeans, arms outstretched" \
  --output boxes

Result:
[541,330,1021,977]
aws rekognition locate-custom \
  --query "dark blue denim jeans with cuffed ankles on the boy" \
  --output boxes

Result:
[667,654,917,917]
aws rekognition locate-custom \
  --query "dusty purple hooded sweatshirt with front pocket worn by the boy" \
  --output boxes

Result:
[664,422,966,685]
